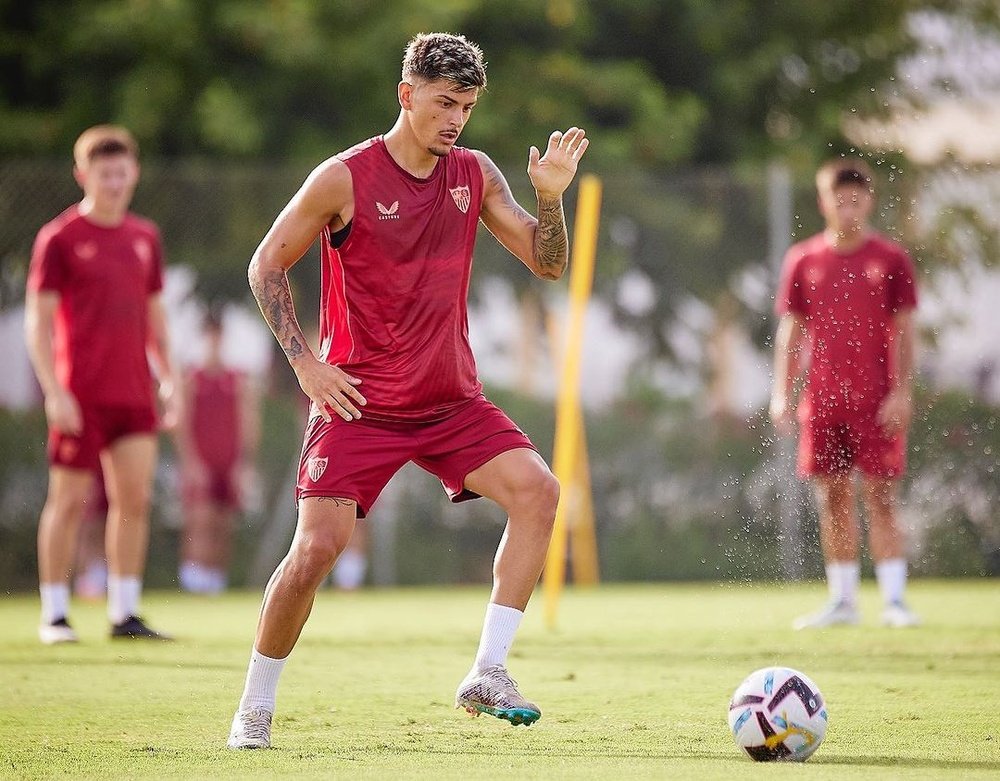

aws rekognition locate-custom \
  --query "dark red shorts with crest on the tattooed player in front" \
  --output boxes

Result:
[295,396,537,518]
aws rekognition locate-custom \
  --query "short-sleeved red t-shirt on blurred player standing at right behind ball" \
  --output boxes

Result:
[775,234,917,420]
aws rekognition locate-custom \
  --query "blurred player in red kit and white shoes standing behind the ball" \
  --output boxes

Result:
[770,158,918,629]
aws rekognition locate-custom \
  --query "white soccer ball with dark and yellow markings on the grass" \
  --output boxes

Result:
[729,667,828,762]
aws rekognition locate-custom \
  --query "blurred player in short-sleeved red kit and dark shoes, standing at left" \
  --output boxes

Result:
[25,125,176,644]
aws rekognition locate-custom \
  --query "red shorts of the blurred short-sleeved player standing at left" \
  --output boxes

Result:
[48,404,157,470]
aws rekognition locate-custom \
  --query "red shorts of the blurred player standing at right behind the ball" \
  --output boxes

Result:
[798,415,906,478]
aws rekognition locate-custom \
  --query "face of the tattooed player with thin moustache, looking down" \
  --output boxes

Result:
[400,79,479,157]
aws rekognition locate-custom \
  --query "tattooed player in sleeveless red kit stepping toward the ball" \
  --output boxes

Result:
[229,33,588,748]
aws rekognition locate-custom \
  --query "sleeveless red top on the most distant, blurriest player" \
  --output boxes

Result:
[189,369,242,469]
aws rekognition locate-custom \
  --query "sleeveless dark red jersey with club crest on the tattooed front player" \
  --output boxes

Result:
[320,136,483,421]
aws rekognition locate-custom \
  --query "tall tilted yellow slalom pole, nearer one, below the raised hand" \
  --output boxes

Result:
[543,174,601,628]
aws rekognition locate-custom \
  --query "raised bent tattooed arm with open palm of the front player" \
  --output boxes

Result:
[477,127,590,279]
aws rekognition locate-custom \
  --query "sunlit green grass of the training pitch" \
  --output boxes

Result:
[0,580,1000,781]
